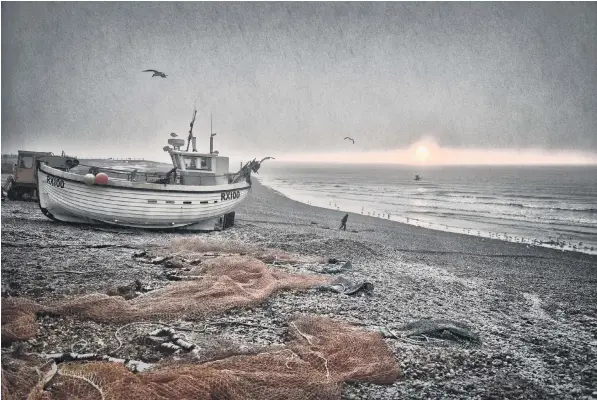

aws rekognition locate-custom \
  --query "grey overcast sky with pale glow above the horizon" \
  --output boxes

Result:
[1,2,597,164]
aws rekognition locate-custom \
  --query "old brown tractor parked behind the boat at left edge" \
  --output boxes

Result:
[2,150,79,200]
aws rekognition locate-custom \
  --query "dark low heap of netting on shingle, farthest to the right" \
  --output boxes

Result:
[398,319,481,343]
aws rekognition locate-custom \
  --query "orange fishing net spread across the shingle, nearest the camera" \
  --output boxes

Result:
[2,315,399,400]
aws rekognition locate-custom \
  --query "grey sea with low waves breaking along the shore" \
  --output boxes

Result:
[257,162,597,254]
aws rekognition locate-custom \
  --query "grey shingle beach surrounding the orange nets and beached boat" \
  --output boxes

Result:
[2,183,597,399]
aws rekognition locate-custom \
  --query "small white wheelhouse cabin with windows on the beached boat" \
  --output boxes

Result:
[169,150,230,185]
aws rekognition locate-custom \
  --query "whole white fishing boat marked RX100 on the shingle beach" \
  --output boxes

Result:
[36,111,270,231]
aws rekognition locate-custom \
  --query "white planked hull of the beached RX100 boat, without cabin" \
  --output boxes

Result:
[37,164,251,231]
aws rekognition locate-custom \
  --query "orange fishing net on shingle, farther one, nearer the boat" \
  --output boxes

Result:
[2,256,329,343]
